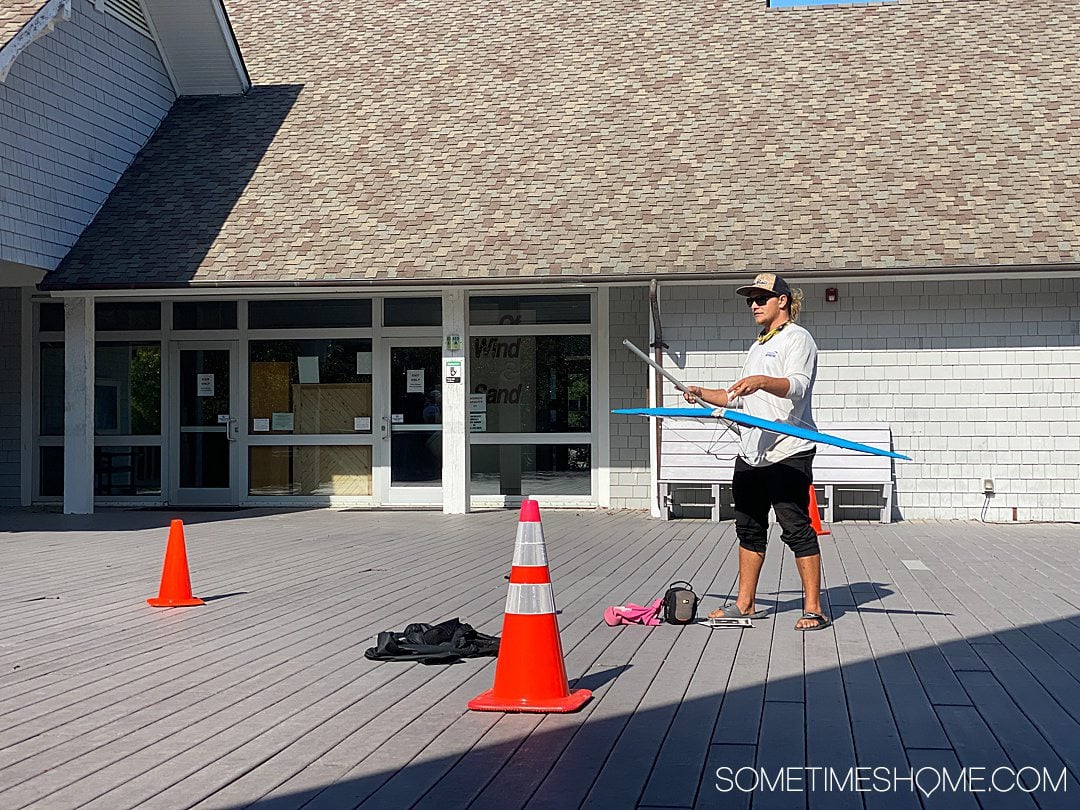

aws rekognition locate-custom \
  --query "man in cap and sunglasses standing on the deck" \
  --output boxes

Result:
[684,273,829,631]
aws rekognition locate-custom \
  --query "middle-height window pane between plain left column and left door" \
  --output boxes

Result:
[94,342,161,436]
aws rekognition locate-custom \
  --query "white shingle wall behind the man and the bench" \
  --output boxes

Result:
[661,278,1080,522]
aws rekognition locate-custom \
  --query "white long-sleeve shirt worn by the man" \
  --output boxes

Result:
[728,323,818,467]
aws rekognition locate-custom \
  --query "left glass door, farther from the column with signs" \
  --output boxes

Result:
[170,341,240,505]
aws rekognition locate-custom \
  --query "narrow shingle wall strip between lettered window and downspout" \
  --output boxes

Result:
[609,287,651,509]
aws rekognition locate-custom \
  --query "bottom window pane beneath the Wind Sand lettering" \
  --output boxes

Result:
[471,444,592,496]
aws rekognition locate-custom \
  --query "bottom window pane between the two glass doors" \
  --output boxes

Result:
[248,445,372,496]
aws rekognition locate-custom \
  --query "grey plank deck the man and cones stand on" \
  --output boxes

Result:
[0,510,1080,810]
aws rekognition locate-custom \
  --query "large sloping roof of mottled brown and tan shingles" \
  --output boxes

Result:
[46,0,1080,288]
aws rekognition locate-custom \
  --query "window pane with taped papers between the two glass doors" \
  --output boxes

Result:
[247,338,372,434]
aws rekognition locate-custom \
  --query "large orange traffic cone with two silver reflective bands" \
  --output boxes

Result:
[469,498,593,712]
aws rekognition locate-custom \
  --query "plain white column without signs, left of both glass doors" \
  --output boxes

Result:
[64,296,94,515]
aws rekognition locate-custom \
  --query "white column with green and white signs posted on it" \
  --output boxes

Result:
[443,287,471,515]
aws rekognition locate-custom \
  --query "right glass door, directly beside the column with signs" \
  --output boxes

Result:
[381,338,443,505]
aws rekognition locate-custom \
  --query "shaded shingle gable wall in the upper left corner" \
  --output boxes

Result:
[0,0,175,270]
